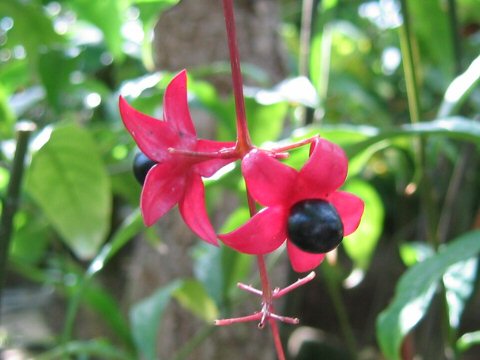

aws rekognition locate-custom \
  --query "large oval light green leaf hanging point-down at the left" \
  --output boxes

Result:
[26,125,111,259]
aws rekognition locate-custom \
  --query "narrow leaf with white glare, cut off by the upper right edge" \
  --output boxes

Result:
[438,56,480,118]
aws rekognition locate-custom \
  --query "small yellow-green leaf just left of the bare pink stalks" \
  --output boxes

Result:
[173,280,218,323]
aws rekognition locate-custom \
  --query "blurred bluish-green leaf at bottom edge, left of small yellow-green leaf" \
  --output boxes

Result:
[130,281,182,360]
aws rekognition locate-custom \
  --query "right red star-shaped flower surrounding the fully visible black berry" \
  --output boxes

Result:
[219,139,364,272]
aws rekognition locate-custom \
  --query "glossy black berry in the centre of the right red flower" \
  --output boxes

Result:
[287,199,343,254]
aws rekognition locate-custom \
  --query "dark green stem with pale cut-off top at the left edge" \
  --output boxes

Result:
[0,121,36,320]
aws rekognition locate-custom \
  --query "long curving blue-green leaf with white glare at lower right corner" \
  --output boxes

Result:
[377,230,480,360]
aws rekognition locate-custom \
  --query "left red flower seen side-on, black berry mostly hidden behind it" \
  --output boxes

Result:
[119,70,235,245]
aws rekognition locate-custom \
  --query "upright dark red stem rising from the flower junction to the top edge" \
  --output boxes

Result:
[223,0,252,155]
